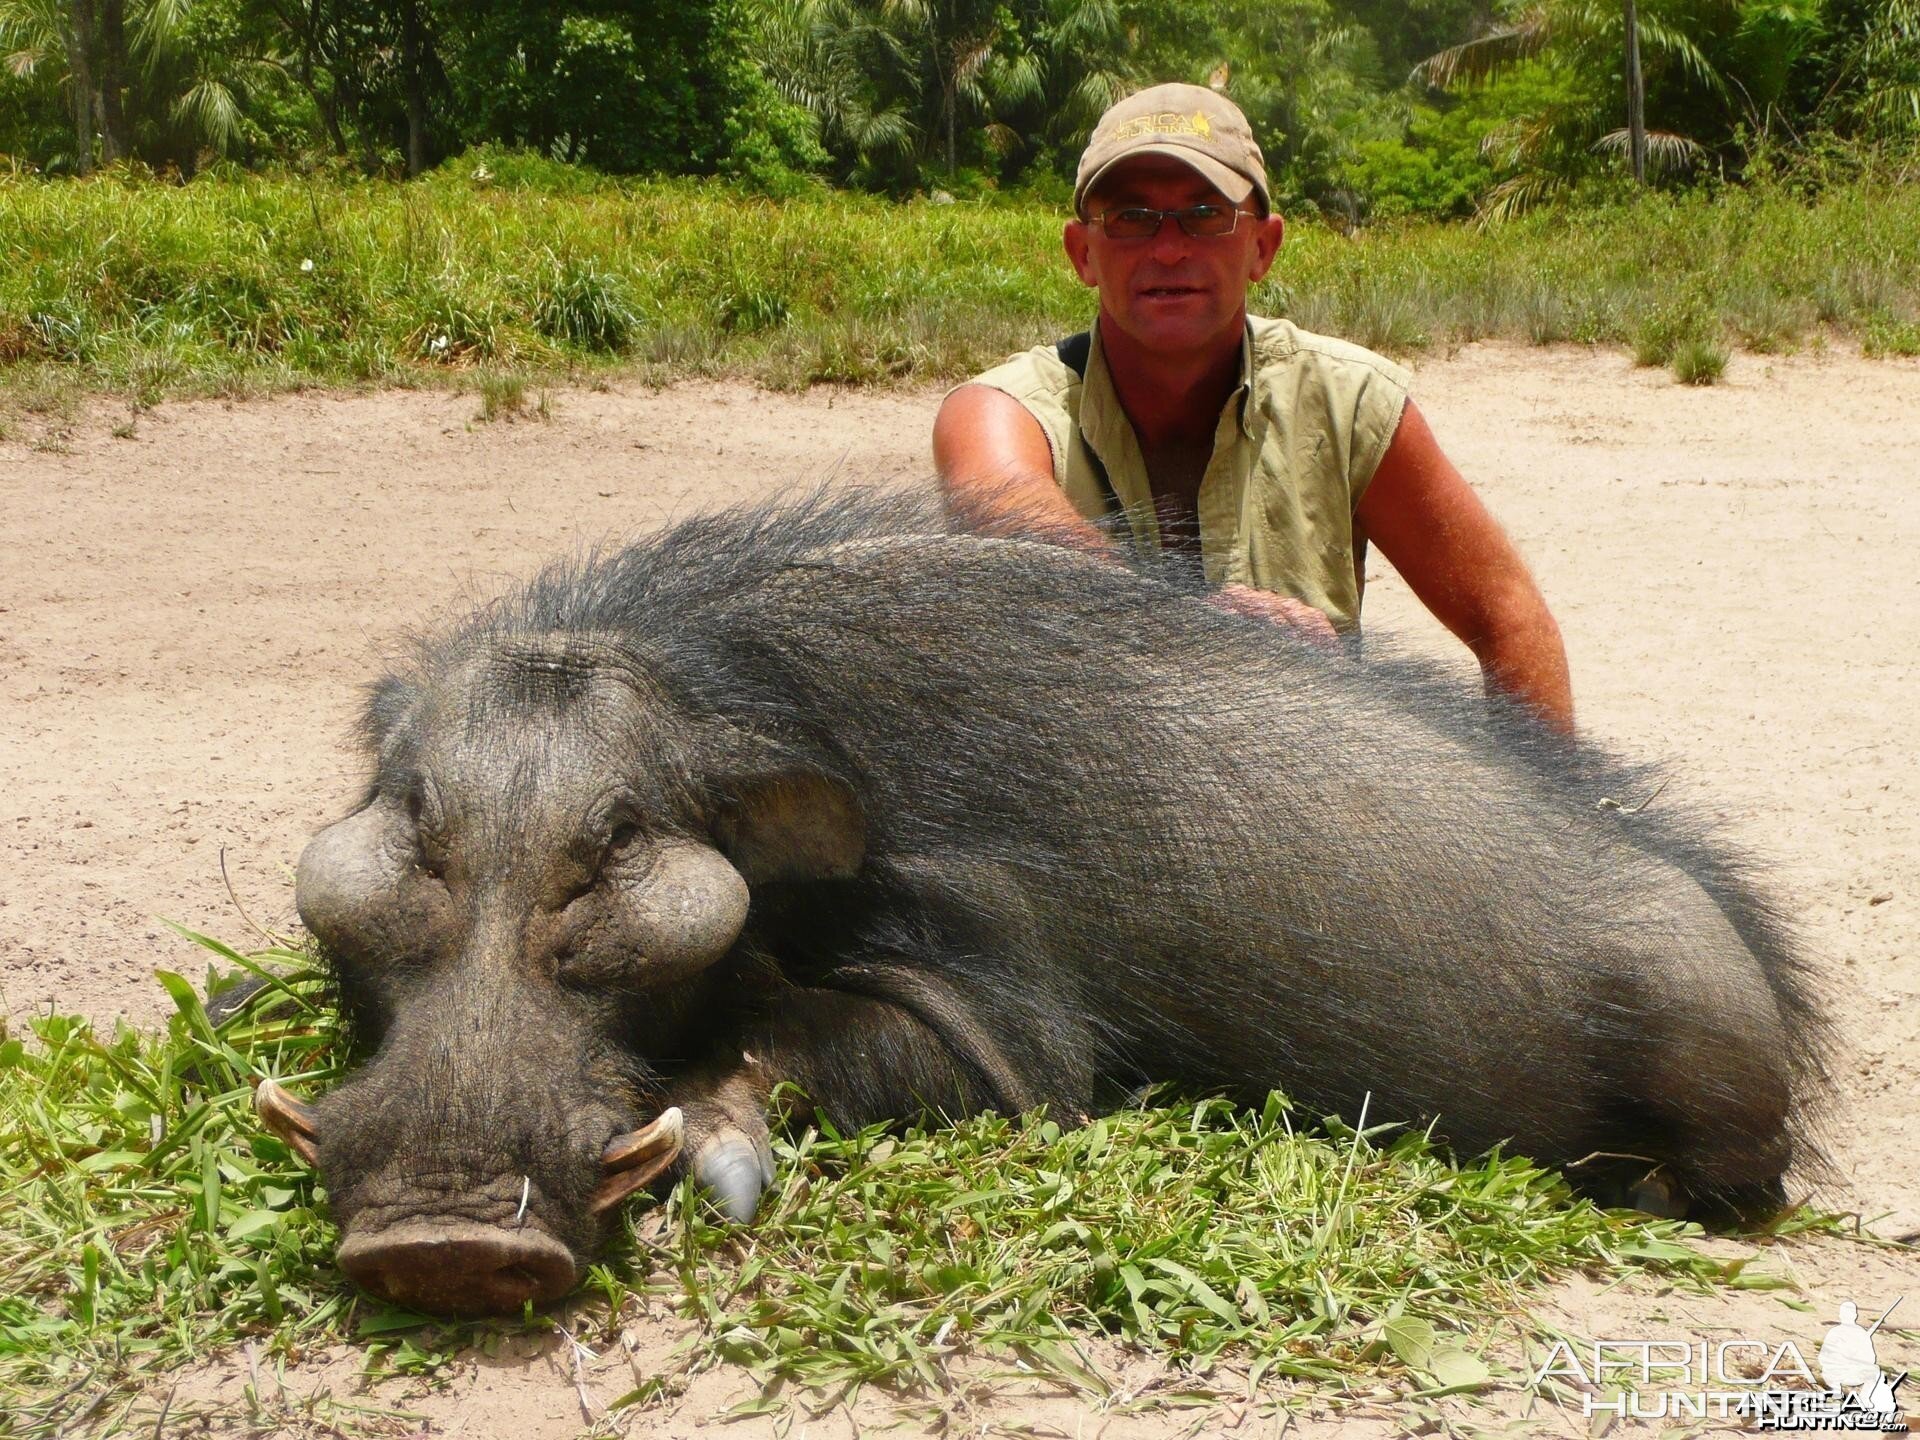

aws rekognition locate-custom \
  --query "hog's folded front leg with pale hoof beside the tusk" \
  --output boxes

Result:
[670,989,1031,1223]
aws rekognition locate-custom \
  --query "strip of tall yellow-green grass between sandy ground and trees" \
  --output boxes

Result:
[0,157,1920,403]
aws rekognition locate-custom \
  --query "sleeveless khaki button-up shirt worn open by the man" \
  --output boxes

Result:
[973,317,1411,630]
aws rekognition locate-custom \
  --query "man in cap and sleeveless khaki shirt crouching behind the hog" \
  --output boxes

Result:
[933,84,1572,733]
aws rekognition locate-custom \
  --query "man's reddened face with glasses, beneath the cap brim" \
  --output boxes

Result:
[1062,156,1284,355]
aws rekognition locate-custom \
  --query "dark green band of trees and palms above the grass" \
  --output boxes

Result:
[0,0,1920,223]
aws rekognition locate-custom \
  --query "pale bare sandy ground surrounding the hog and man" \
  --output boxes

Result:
[0,346,1920,1440]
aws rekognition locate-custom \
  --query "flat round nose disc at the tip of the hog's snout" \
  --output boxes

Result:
[336,1219,578,1315]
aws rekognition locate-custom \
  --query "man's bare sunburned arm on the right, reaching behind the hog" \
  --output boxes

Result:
[1356,399,1572,735]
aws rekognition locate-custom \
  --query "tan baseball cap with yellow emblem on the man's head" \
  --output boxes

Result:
[1073,84,1273,215]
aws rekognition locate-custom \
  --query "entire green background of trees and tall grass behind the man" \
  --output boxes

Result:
[0,0,1920,403]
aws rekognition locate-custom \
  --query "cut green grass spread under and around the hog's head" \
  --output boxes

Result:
[0,937,1820,1436]
